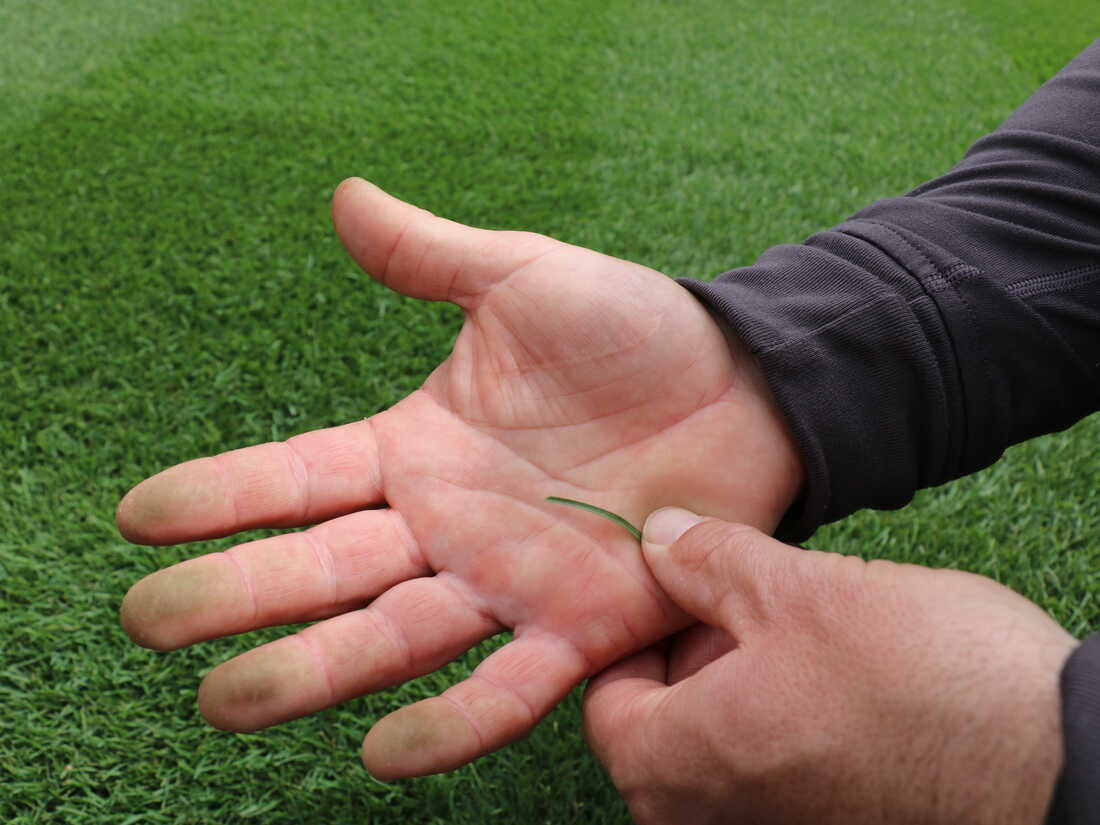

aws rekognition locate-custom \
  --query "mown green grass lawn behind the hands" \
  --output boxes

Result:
[0,0,1100,825]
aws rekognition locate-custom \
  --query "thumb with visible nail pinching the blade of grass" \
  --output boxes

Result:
[642,507,804,636]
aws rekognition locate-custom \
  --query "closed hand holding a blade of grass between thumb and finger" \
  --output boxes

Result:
[584,510,1076,825]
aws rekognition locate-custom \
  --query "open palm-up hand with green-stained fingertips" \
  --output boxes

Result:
[118,179,802,778]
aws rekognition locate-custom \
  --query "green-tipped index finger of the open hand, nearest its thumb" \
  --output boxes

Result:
[116,419,384,545]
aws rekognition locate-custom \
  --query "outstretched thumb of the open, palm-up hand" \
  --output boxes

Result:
[332,177,556,308]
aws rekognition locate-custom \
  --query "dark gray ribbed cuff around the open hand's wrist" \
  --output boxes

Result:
[680,221,968,543]
